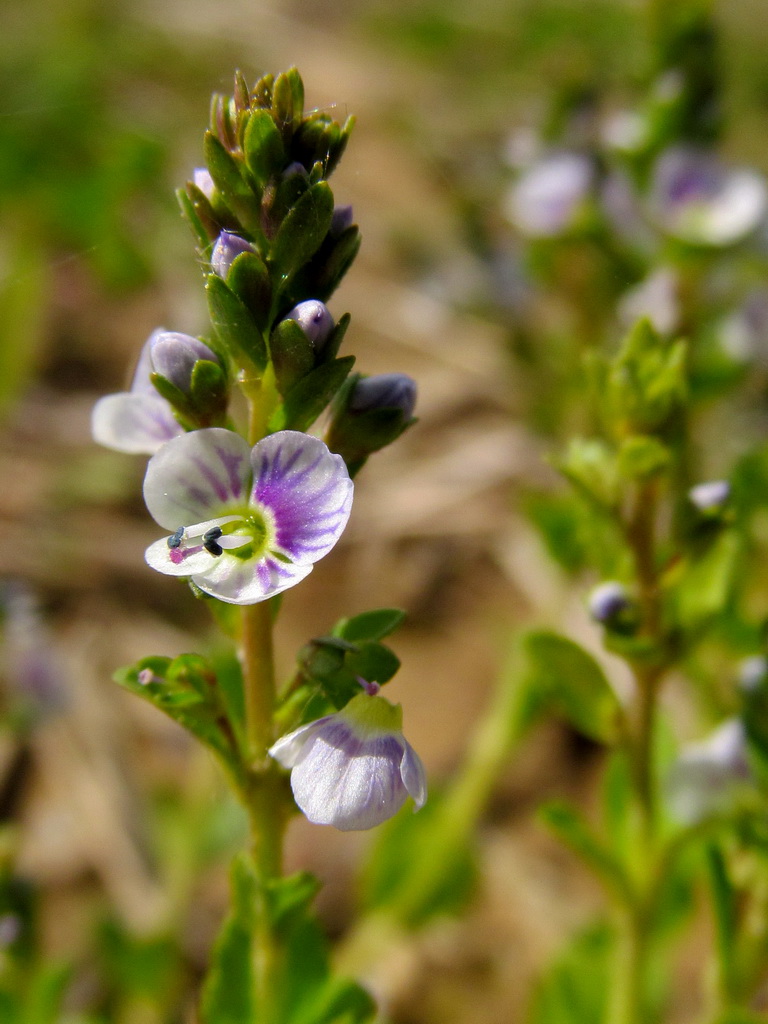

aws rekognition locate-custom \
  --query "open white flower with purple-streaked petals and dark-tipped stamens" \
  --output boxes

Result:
[144,427,353,604]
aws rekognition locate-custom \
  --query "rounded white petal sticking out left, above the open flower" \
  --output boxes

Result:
[91,391,184,455]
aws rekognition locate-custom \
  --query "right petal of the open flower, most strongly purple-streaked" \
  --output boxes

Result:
[251,430,354,565]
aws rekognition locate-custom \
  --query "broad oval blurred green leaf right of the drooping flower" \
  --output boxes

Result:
[523,631,622,743]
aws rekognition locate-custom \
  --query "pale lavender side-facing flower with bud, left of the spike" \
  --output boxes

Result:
[91,328,219,455]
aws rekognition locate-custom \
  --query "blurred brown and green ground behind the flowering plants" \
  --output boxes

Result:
[0,0,768,1024]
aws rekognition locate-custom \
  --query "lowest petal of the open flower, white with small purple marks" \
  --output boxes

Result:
[193,551,312,604]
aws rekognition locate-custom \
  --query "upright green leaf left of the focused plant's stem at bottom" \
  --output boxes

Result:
[201,856,259,1024]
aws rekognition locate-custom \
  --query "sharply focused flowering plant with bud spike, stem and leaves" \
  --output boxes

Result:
[93,69,426,1024]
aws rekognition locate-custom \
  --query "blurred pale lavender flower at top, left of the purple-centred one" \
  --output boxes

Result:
[505,153,594,238]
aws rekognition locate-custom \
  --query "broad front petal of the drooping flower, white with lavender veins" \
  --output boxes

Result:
[291,722,408,831]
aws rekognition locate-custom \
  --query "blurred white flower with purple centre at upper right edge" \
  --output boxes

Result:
[650,146,768,246]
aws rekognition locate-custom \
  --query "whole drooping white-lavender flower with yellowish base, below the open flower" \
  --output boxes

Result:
[269,692,427,831]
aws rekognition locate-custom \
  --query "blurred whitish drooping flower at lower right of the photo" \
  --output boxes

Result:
[666,718,754,824]
